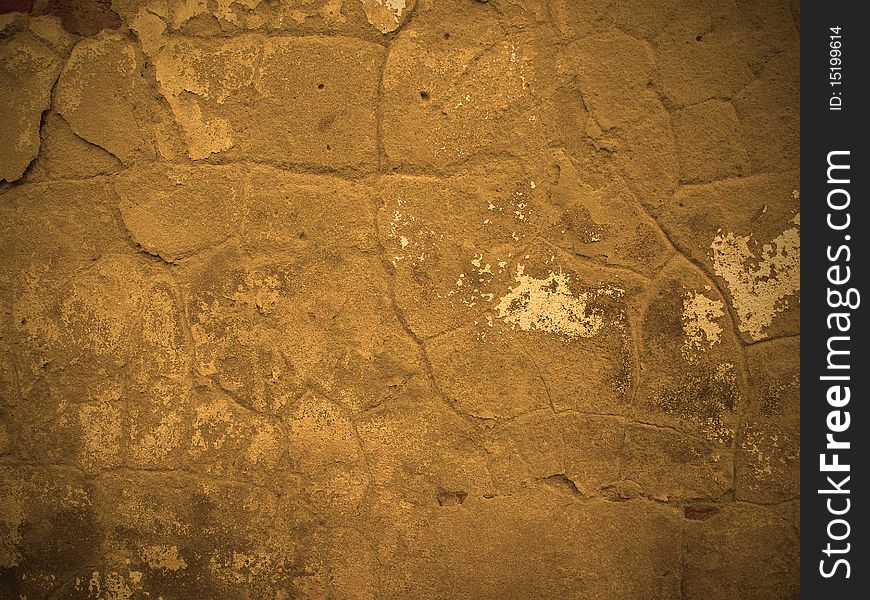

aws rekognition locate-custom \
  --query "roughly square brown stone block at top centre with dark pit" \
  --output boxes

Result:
[381,2,555,170]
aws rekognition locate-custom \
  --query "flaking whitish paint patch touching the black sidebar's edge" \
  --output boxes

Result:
[710,213,801,340]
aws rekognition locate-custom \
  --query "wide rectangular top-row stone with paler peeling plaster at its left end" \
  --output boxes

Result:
[151,36,383,171]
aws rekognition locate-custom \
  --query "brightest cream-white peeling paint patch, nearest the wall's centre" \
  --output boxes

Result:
[495,265,622,338]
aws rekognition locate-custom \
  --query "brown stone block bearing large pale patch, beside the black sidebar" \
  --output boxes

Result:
[660,171,800,341]
